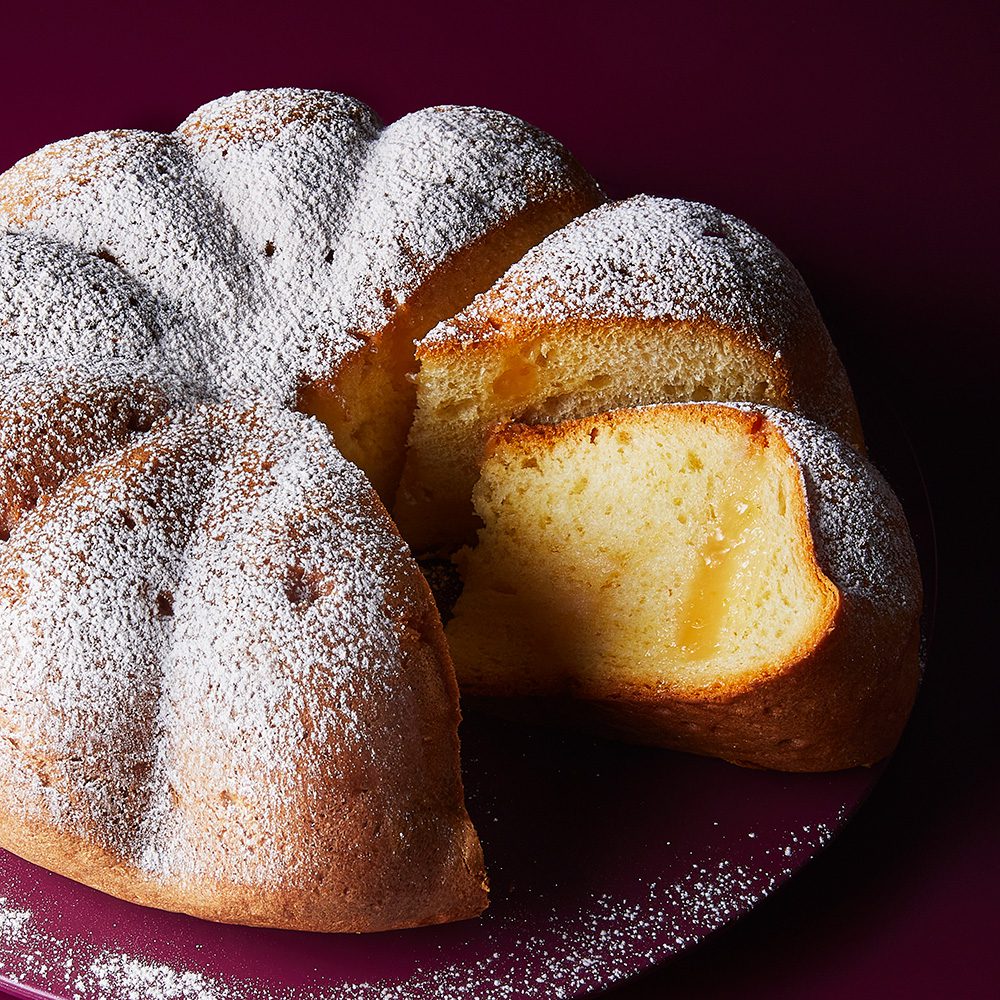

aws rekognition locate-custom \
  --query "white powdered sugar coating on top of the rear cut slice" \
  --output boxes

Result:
[422,195,818,352]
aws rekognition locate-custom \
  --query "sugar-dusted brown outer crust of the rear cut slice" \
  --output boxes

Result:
[418,195,860,442]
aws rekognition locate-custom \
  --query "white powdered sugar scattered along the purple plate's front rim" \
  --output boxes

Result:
[0,808,846,1000]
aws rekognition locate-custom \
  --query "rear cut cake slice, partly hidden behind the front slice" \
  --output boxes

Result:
[394,196,863,551]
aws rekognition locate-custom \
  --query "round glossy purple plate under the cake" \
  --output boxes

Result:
[0,384,936,1000]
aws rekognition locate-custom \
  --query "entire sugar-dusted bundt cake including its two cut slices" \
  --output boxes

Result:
[0,89,919,931]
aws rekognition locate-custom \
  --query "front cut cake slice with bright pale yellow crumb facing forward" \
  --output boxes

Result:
[447,403,921,771]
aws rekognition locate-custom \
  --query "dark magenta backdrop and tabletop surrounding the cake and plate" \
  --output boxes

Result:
[0,0,1000,1000]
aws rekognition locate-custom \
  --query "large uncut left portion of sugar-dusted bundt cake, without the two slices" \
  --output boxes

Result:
[0,89,602,931]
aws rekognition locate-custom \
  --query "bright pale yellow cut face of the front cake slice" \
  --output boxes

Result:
[448,406,835,696]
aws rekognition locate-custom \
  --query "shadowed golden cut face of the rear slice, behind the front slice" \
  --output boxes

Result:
[395,319,788,551]
